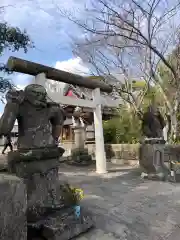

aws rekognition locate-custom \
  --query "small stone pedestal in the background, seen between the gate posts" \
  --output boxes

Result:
[67,126,92,166]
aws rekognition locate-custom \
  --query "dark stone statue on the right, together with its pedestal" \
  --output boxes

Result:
[139,105,169,180]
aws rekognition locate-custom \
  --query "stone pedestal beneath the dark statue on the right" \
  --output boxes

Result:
[139,139,169,180]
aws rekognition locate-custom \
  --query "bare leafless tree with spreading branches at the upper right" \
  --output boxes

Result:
[53,0,180,136]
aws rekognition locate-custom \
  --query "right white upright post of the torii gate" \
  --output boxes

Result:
[92,88,107,174]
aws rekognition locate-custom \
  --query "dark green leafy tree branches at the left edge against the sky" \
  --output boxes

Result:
[0,22,34,93]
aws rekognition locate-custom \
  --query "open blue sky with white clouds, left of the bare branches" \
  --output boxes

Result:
[0,0,88,113]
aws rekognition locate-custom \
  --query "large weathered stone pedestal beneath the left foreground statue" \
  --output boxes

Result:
[8,148,92,240]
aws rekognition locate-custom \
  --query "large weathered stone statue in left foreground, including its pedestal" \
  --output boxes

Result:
[0,84,92,240]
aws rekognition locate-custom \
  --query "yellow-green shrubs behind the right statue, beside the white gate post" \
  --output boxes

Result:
[103,86,164,144]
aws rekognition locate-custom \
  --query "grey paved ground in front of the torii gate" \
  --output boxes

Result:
[60,164,180,240]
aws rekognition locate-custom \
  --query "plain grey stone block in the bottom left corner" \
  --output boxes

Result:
[0,173,27,240]
